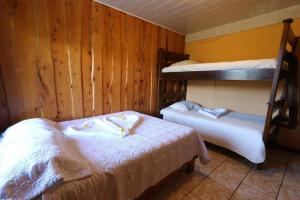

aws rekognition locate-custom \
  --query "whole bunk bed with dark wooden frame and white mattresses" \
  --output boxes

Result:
[157,19,300,164]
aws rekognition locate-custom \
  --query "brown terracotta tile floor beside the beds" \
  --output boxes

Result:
[141,146,300,200]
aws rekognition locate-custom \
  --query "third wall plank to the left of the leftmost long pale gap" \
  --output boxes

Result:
[12,1,41,118]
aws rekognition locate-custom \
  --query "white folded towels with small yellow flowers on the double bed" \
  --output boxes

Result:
[64,114,142,137]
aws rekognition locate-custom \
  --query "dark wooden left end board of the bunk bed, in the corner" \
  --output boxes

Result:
[157,49,190,116]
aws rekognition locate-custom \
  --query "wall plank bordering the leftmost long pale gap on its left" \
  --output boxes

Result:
[48,0,74,120]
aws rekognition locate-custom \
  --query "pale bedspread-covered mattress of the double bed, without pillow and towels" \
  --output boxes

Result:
[41,111,208,199]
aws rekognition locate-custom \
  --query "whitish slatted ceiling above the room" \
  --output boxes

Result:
[96,0,300,34]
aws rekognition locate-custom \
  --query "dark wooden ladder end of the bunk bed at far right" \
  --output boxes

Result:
[263,19,299,145]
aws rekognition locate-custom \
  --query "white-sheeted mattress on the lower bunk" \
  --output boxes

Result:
[161,108,266,163]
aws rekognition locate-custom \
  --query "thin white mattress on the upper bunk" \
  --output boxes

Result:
[162,59,277,73]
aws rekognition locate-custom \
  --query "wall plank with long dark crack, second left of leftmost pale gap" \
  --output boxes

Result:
[32,0,57,119]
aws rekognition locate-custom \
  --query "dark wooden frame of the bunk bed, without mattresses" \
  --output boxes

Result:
[157,19,300,152]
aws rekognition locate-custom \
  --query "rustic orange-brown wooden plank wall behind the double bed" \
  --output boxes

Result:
[0,0,184,129]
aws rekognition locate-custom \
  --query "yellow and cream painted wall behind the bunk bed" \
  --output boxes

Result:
[185,19,300,149]
